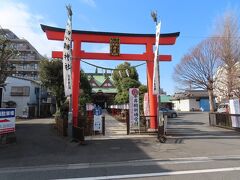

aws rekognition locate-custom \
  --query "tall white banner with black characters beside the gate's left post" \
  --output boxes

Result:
[63,5,72,96]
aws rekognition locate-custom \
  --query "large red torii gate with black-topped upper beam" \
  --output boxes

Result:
[41,25,180,129]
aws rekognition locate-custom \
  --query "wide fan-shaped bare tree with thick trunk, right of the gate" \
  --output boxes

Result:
[174,38,220,111]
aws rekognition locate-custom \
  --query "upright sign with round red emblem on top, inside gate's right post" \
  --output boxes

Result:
[129,88,140,129]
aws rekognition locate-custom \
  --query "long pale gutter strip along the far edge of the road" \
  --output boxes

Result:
[0,155,240,174]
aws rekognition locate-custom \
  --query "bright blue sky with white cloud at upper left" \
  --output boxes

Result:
[0,0,240,94]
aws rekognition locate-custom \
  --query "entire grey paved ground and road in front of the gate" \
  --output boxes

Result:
[0,113,240,180]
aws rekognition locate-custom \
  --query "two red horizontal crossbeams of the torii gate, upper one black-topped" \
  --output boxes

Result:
[41,25,180,61]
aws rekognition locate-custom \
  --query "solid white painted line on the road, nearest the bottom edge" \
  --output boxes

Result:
[57,167,240,180]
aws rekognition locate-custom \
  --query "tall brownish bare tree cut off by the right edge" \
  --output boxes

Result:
[215,12,240,99]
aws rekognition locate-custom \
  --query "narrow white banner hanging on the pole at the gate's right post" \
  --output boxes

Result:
[153,22,161,95]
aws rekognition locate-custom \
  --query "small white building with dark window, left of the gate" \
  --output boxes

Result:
[2,77,41,118]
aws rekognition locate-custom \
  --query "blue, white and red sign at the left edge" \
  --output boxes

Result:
[0,108,16,135]
